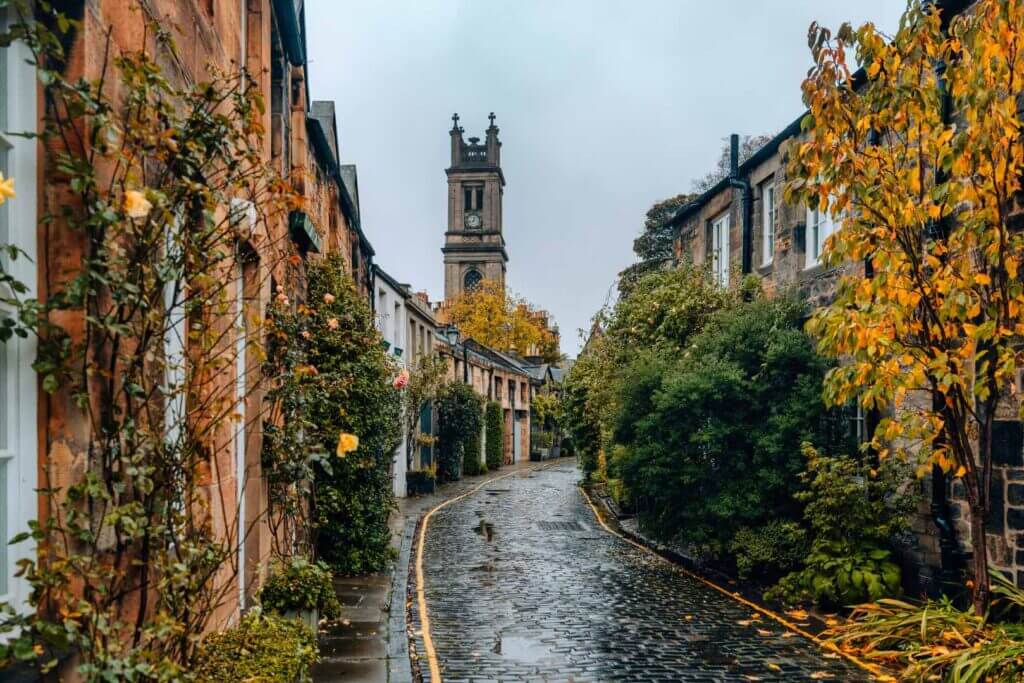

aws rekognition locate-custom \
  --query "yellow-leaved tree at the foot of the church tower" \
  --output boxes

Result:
[447,280,560,361]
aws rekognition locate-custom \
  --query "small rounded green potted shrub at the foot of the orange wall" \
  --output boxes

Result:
[259,557,341,620]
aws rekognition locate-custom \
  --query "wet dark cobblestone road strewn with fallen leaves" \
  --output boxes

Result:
[412,463,868,683]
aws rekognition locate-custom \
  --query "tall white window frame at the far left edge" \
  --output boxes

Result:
[0,14,39,611]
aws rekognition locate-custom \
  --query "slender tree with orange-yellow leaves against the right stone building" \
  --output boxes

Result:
[786,0,1024,613]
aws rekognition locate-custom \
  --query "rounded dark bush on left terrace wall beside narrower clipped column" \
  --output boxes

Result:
[436,382,483,481]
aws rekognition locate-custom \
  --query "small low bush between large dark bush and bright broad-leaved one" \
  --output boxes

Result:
[729,520,807,583]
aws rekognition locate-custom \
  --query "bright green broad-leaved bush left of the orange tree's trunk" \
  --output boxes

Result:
[771,444,913,606]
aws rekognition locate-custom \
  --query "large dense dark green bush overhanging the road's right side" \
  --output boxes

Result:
[612,298,829,557]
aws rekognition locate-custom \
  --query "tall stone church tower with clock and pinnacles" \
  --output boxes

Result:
[441,113,509,300]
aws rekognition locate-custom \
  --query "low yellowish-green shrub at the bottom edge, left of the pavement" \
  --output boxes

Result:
[194,610,319,683]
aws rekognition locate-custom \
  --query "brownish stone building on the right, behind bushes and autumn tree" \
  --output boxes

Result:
[671,0,1024,592]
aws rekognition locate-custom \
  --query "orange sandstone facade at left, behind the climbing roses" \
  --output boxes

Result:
[0,0,373,655]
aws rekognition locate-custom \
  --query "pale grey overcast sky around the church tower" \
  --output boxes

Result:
[306,0,905,355]
